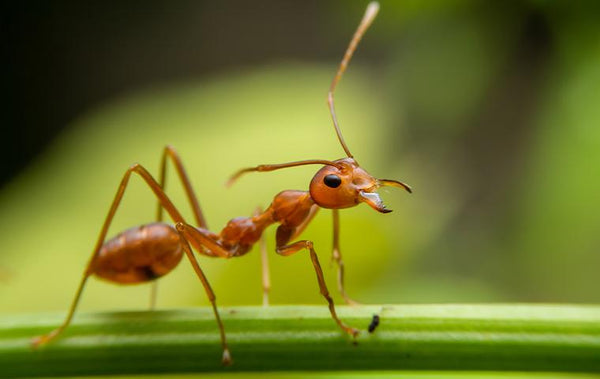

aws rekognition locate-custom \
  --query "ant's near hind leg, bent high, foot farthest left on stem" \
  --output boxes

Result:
[32,164,188,348]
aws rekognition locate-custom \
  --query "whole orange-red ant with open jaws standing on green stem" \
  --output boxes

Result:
[32,2,411,365]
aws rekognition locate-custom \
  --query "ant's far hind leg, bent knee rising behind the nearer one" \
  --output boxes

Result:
[150,145,207,310]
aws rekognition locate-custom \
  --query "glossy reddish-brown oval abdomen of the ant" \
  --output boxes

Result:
[91,222,183,284]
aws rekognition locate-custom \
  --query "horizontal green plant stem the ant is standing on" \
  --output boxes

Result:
[0,305,600,377]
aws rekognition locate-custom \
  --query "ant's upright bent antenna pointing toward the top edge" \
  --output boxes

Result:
[327,1,379,158]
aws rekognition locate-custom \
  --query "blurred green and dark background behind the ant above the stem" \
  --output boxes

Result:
[0,0,600,312]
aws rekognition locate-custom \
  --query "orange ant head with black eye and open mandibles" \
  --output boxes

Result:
[310,158,411,213]
